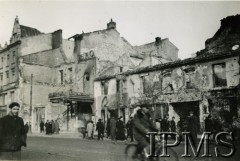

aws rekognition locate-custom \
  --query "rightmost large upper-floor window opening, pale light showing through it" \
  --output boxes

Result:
[213,63,227,87]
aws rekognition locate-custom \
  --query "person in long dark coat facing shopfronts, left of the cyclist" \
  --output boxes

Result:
[116,116,126,141]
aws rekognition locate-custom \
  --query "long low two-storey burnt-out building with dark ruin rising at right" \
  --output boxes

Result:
[94,15,240,129]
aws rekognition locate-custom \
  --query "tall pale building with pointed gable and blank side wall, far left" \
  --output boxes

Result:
[0,17,74,130]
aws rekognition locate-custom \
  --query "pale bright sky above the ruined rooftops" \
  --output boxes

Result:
[0,0,240,59]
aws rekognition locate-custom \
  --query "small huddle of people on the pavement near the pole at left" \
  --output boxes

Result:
[39,120,60,135]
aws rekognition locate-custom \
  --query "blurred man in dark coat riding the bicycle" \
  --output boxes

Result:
[133,107,158,156]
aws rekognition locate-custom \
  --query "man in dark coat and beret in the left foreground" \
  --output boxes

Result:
[0,102,27,161]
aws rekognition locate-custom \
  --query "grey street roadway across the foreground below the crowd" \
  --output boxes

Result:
[19,133,240,161]
